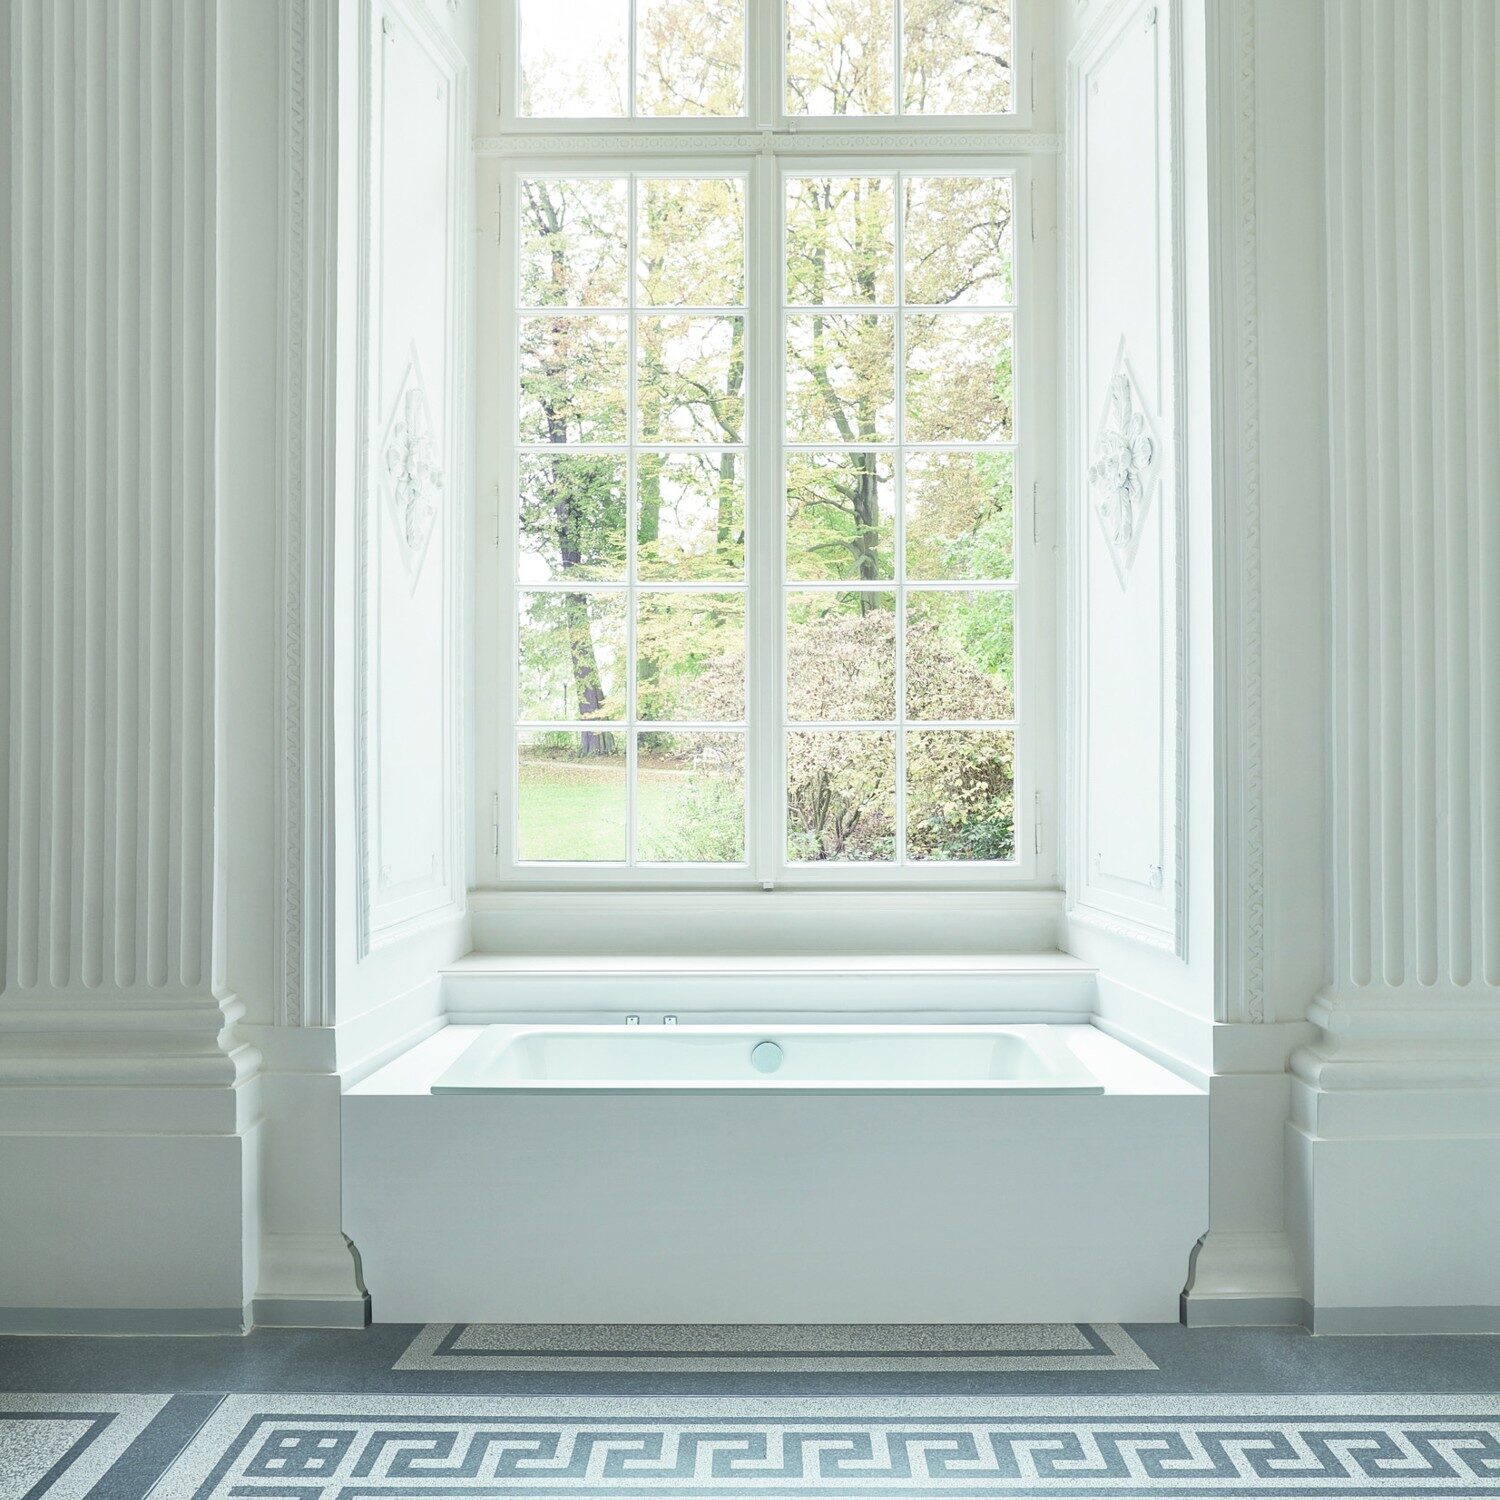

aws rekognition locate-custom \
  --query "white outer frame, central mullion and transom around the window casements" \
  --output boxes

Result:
[473,0,1061,891]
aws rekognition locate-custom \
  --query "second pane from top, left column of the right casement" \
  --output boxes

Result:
[786,312,896,443]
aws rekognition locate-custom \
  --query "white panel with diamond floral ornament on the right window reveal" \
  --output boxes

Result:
[1067,0,1187,956]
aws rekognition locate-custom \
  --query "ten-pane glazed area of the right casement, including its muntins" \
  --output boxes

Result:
[783,171,1017,866]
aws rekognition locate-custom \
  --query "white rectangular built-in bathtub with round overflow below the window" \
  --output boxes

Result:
[432,1025,1104,1094]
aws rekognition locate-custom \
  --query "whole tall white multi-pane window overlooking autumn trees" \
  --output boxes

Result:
[480,0,1050,884]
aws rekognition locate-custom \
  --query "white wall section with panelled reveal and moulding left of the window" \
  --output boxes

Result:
[255,0,474,1325]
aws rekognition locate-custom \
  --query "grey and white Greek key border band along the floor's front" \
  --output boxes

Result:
[138,1397,1500,1500]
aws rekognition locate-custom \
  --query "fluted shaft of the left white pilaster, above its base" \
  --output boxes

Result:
[0,0,216,1008]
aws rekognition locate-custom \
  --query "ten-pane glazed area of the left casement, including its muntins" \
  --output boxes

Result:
[512,171,749,866]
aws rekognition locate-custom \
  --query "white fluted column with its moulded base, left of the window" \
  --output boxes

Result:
[0,0,258,1328]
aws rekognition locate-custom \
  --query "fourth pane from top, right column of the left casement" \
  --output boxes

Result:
[636,593,746,723]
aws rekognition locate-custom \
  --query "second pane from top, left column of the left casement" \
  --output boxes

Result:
[521,314,627,443]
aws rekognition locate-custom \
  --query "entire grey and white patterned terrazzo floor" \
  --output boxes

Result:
[0,1325,1500,1500]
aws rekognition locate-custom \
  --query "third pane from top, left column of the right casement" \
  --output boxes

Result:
[786,449,896,582]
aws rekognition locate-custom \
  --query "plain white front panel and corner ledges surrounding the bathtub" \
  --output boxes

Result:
[344,1026,1208,1323]
